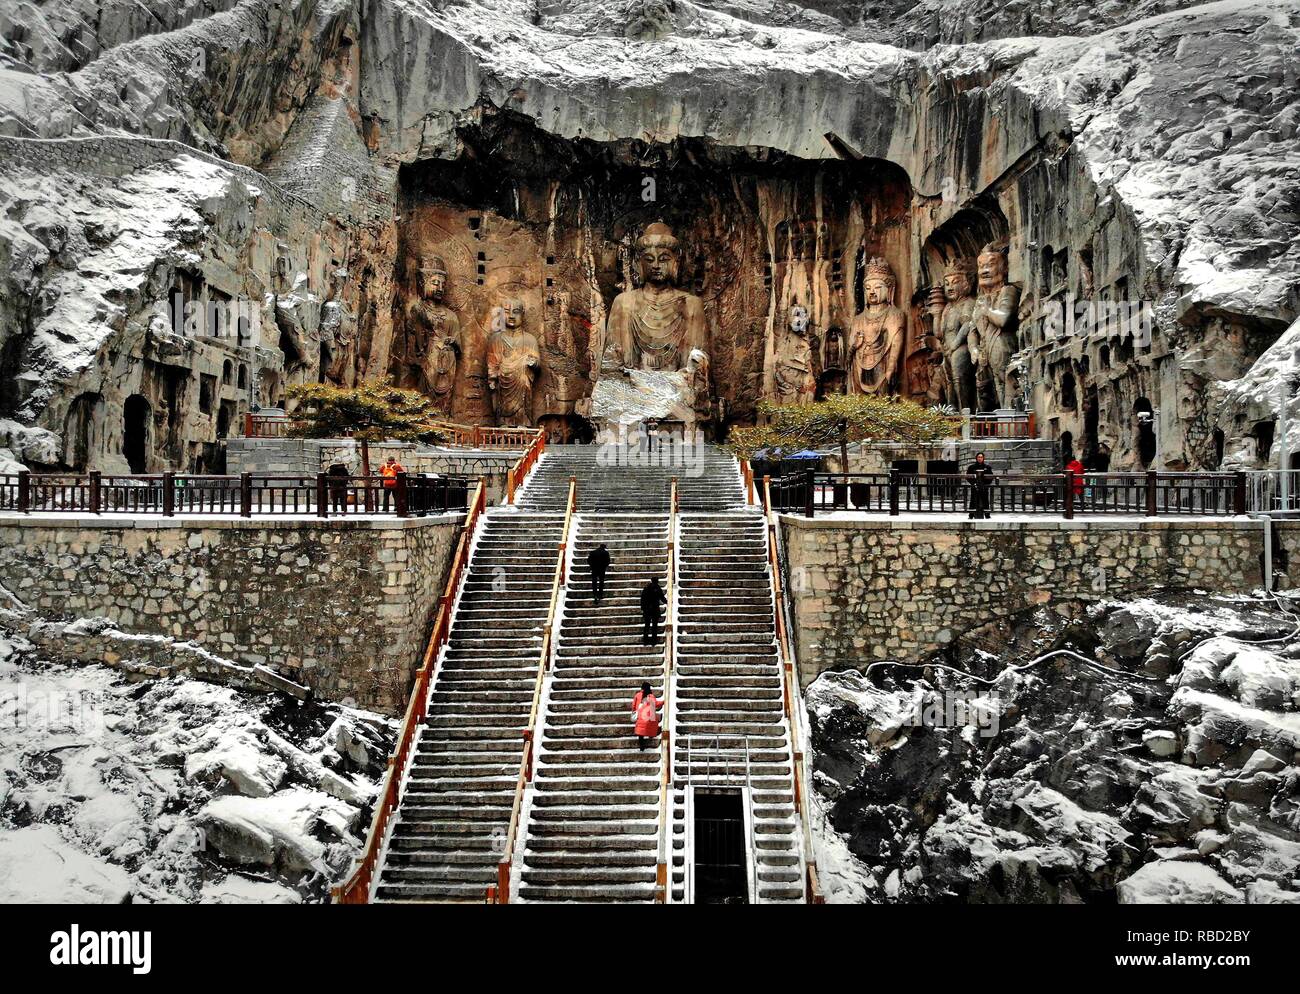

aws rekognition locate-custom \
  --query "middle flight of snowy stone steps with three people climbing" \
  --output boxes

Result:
[519,514,668,902]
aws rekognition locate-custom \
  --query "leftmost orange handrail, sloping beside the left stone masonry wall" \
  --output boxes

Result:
[333,478,488,904]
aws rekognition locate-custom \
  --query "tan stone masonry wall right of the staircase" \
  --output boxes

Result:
[781,515,1264,682]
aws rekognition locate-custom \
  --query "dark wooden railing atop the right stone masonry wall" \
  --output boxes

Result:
[770,470,1247,518]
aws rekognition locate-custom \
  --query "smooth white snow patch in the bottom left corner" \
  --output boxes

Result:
[0,815,133,904]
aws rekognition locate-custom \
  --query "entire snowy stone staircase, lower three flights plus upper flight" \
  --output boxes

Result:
[371,446,806,903]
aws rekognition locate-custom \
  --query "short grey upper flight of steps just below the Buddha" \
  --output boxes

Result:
[519,443,745,515]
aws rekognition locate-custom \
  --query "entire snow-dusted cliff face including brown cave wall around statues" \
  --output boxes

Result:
[0,0,1300,472]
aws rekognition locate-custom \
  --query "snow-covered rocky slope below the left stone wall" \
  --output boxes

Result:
[0,631,394,902]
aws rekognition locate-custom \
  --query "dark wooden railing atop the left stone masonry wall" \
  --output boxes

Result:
[0,472,471,517]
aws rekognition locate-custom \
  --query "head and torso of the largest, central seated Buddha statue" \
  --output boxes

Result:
[605,221,709,372]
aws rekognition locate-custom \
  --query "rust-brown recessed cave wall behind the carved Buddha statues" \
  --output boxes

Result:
[387,113,915,437]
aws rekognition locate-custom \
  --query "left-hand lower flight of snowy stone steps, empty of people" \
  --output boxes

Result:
[374,511,564,902]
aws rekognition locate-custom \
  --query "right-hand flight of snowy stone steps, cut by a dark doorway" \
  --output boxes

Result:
[672,513,803,903]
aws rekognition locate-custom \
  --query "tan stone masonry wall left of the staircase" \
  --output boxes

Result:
[0,515,463,713]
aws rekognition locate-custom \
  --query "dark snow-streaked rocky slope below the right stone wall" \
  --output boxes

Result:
[805,595,1300,903]
